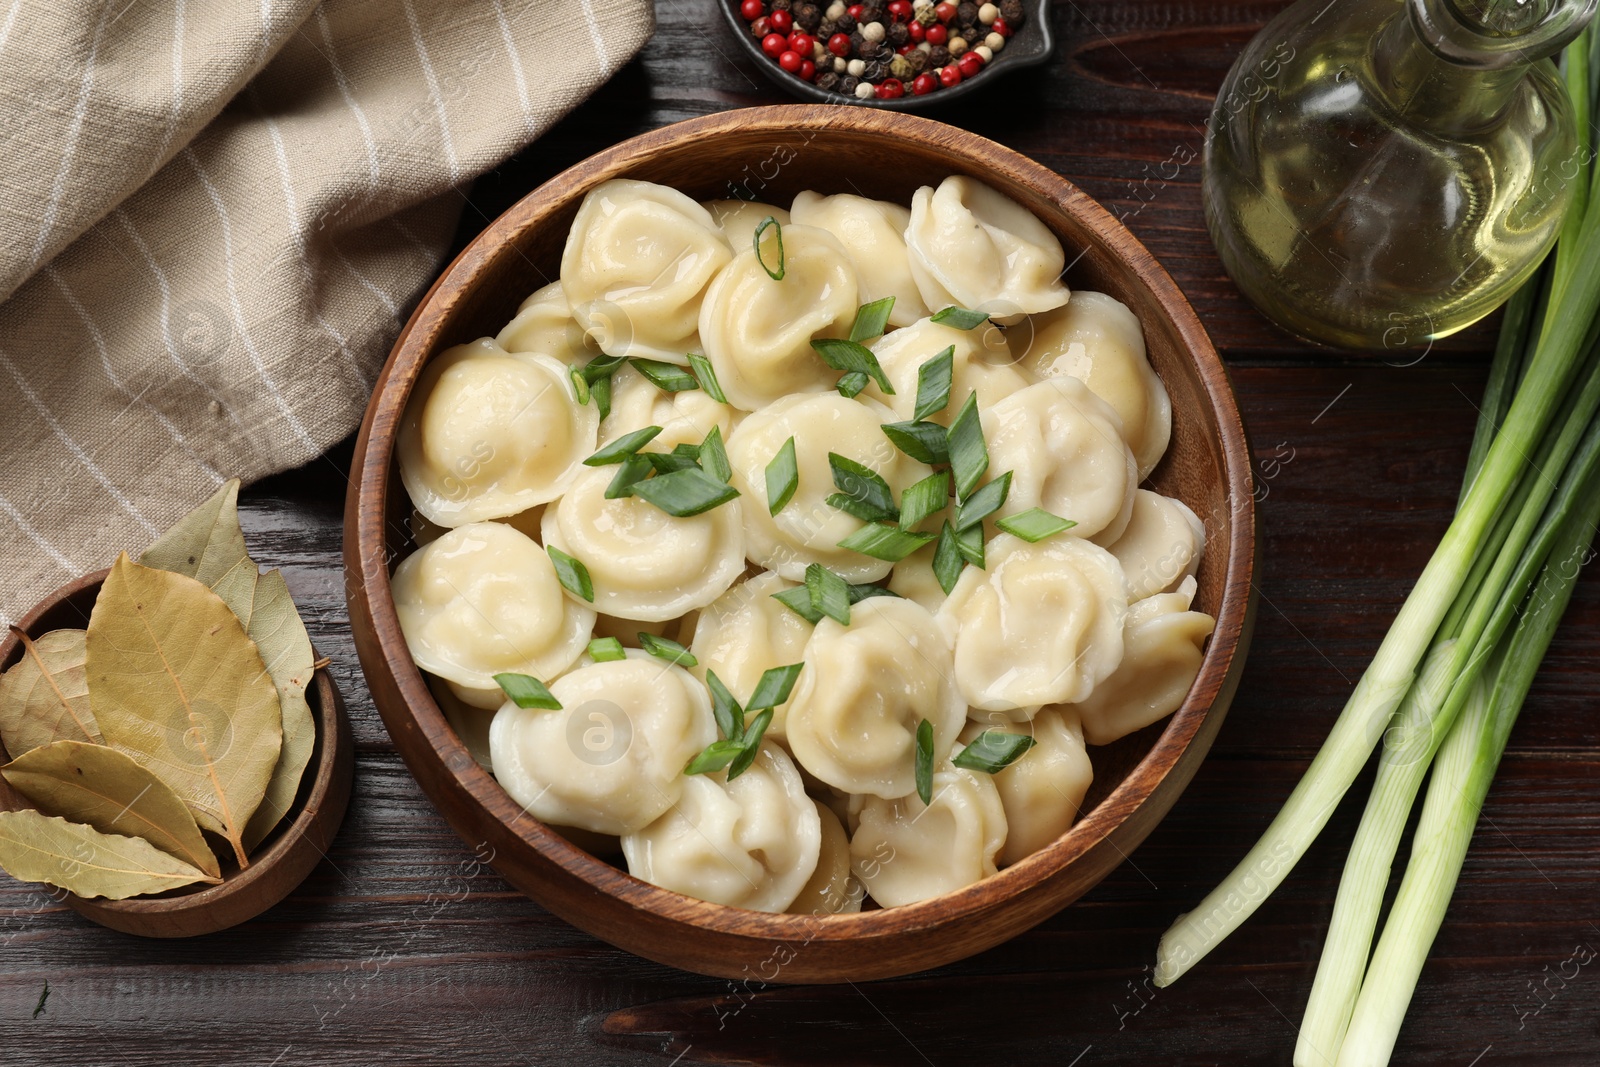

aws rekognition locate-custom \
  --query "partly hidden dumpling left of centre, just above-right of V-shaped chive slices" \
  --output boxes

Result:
[690,571,811,741]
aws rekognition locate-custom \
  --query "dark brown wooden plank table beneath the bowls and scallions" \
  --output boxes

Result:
[0,0,1600,1067]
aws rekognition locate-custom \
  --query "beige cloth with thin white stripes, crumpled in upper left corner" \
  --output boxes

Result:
[0,0,653,622]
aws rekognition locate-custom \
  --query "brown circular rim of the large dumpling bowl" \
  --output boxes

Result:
[346,104,1258,950]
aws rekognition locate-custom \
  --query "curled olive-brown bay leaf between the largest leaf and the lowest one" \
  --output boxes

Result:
[0,741,222,878]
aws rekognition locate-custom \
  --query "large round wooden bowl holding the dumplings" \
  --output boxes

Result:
[344,106,1256,982]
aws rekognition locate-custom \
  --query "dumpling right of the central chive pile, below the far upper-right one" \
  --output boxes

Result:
[978,378,1138,537]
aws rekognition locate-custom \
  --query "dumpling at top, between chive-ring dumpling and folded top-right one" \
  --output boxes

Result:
[786,190,938,326]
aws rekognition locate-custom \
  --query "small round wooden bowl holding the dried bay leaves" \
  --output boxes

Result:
[0,569,355,937]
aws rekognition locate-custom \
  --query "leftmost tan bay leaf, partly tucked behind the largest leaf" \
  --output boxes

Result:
[0,627,101,757]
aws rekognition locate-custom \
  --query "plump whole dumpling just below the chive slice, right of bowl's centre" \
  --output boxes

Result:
[938,533,1128,718]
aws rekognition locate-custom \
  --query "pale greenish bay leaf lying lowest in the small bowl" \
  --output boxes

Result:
[0,811,216,901]
